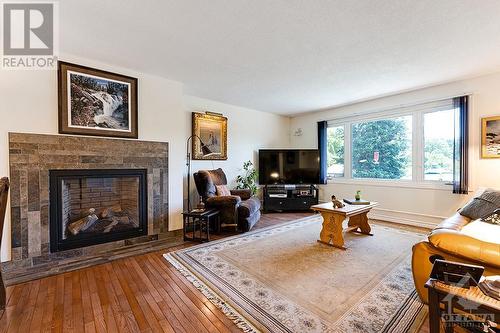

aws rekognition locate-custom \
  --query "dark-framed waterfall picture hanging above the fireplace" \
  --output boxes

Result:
[58,61,138,139]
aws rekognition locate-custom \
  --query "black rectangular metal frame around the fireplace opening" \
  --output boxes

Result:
[49,169,148,253]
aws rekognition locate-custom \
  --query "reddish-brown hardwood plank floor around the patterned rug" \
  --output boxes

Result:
[0,213,436,333]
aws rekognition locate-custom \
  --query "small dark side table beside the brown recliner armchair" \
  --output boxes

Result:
[182,209,220,242]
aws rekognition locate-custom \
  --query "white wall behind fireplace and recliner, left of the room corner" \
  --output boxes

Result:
[0,55,289,261]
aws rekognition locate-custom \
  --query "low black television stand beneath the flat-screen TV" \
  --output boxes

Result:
[264,184,318,212]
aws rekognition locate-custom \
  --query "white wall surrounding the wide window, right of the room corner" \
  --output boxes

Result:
[290,73,500,225]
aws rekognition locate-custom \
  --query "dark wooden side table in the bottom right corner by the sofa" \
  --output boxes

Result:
[425,279,500,333]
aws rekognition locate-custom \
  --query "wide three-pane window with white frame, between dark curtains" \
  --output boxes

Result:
[327,99,455,184]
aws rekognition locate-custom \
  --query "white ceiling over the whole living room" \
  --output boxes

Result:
[60,0,500,115]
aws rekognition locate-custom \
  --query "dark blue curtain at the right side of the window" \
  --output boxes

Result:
[453,96,469,194]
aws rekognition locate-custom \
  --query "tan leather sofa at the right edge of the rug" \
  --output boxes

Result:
[412,213,500,303]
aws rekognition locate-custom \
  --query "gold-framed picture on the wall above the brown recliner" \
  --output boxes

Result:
[192,112,227,160]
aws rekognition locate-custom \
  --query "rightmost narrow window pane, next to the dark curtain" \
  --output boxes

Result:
[424,110,454,182]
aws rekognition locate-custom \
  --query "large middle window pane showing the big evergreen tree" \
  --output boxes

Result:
[351,116,412,179]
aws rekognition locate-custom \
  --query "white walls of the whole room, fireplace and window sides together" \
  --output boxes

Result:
[0,55,500,261]
